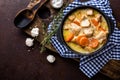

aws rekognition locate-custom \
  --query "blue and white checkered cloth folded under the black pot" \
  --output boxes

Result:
[48,0,120,78]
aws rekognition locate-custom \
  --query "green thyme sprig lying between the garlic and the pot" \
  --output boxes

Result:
[40,4,67,53]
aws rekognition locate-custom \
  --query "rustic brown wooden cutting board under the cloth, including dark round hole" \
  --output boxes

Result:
[20,0,120,80]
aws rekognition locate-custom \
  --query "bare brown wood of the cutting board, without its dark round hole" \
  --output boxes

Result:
[22,0,120,79]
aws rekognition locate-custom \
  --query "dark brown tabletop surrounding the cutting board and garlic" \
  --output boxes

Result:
[0,0,120,80]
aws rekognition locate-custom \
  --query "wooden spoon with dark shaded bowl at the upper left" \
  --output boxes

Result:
[14,0,46,28]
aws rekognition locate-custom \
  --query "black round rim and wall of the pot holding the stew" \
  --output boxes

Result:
[57,6,111,55]
